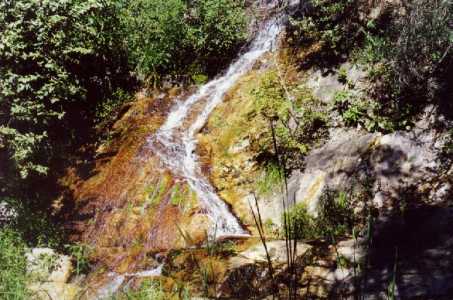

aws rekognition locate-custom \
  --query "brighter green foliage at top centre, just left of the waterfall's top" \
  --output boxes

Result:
[122,0,246,83]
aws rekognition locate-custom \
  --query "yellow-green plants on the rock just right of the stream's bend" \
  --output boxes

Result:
[252,70,327,170]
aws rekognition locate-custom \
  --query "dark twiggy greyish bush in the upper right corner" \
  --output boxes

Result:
[358,0,453,118]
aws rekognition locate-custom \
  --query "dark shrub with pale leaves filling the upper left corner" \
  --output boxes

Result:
[0,0,127,178]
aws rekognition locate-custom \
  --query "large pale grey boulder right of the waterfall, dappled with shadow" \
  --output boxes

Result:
[290,123,449,216]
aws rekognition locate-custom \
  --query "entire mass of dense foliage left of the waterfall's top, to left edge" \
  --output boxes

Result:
[0,0,246,195]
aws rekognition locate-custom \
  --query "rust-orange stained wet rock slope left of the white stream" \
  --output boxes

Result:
[61,89,200,272]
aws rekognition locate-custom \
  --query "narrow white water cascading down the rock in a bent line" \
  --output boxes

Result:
[148,1,281,238]
